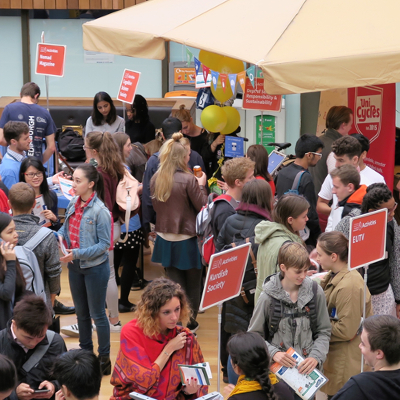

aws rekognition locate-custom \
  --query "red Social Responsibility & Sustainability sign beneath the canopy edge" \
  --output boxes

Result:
[242,78,282,112]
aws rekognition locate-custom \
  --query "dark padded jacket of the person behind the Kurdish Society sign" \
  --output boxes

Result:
[215,203,271,334]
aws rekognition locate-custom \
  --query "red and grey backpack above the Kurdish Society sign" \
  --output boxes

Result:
[196,193,237,266]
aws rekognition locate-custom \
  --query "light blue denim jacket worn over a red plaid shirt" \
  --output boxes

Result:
[58,194,111,268]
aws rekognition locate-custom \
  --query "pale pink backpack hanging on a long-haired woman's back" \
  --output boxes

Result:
[116,170,140,243]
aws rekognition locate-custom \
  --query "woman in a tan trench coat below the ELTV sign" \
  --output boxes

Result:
[317,232,372,399]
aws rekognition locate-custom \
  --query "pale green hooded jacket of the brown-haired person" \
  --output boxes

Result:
[254,221,303,302]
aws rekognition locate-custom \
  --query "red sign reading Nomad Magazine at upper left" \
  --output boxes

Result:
[36,43,67,76]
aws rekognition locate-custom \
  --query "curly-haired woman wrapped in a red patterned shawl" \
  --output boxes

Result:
[111,278,208,400]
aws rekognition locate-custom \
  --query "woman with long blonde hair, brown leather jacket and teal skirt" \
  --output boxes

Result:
[150,133,207,331]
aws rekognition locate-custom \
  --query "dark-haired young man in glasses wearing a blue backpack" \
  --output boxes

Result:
[276,134,324,247]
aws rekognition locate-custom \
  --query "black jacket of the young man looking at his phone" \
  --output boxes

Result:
[0,320,67,400]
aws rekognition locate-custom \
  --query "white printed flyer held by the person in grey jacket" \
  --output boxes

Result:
[270,348,328,400]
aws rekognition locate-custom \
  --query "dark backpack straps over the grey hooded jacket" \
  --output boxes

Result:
[264,275,318,342]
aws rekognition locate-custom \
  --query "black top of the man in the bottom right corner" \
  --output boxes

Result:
[332,369,400,400]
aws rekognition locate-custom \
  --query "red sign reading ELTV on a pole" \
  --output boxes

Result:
[348,208,387,270]
